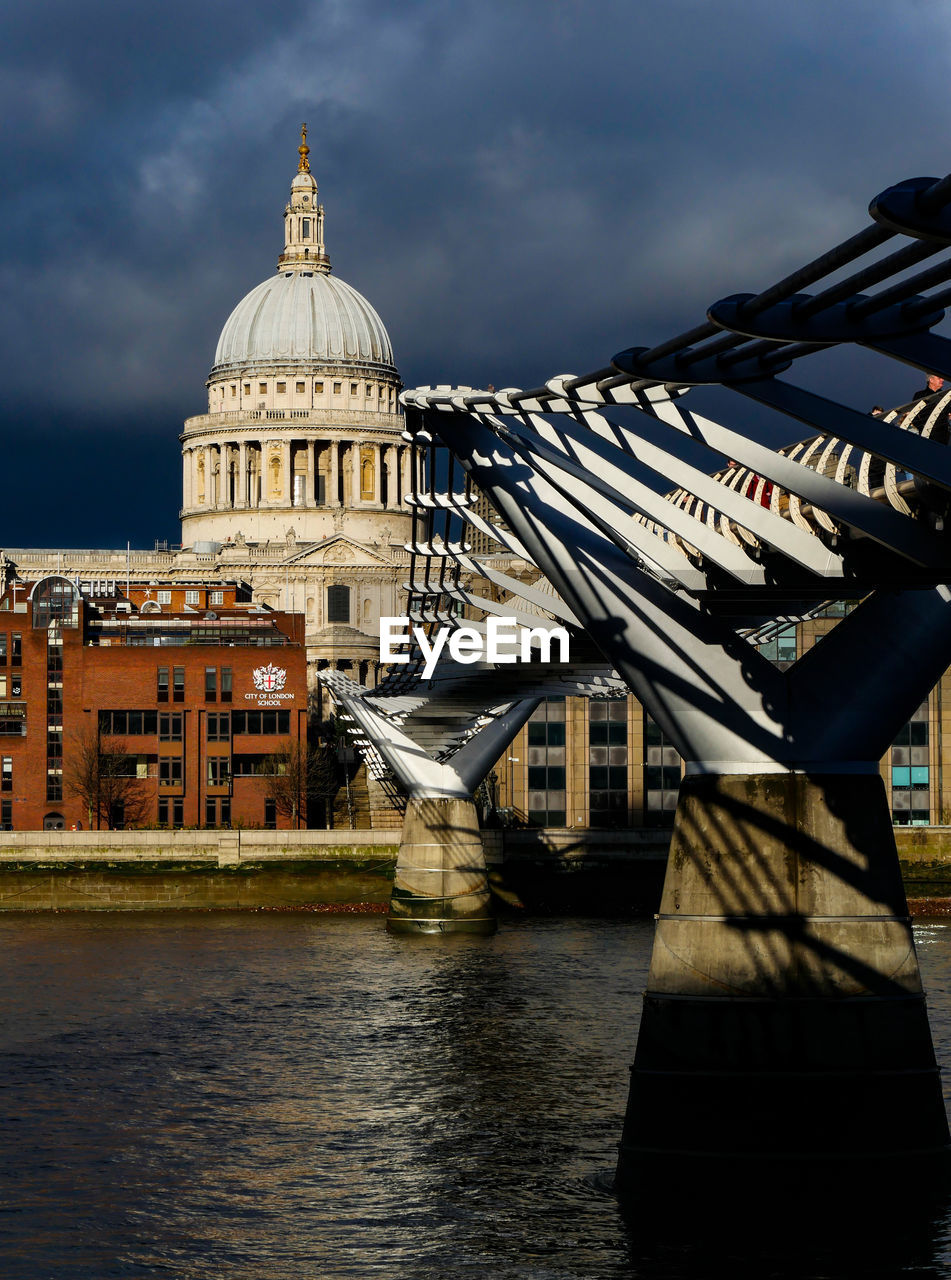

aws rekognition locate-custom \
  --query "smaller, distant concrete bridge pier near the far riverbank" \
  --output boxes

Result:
[387,796,497,934]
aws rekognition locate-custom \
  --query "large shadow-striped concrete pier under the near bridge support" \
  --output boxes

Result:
[616,771,948,1198]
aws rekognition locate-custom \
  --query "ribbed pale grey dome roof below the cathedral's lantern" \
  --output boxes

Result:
[211,269,397,381]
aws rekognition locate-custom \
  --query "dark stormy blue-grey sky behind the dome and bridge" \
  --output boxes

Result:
[0,0,951,548]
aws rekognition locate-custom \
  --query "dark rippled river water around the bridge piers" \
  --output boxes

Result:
[0,913,951,1280]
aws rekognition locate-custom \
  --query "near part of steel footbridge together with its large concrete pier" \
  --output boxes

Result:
[403,175,951,1194]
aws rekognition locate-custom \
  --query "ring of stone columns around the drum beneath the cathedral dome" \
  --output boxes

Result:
[182,438,412,511]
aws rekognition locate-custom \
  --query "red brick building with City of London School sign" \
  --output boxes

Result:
[0,576,307,831]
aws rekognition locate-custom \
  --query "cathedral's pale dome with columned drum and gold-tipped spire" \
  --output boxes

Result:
[182,132,412,576]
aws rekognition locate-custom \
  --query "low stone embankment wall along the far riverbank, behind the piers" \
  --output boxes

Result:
[0,827,951,914]
